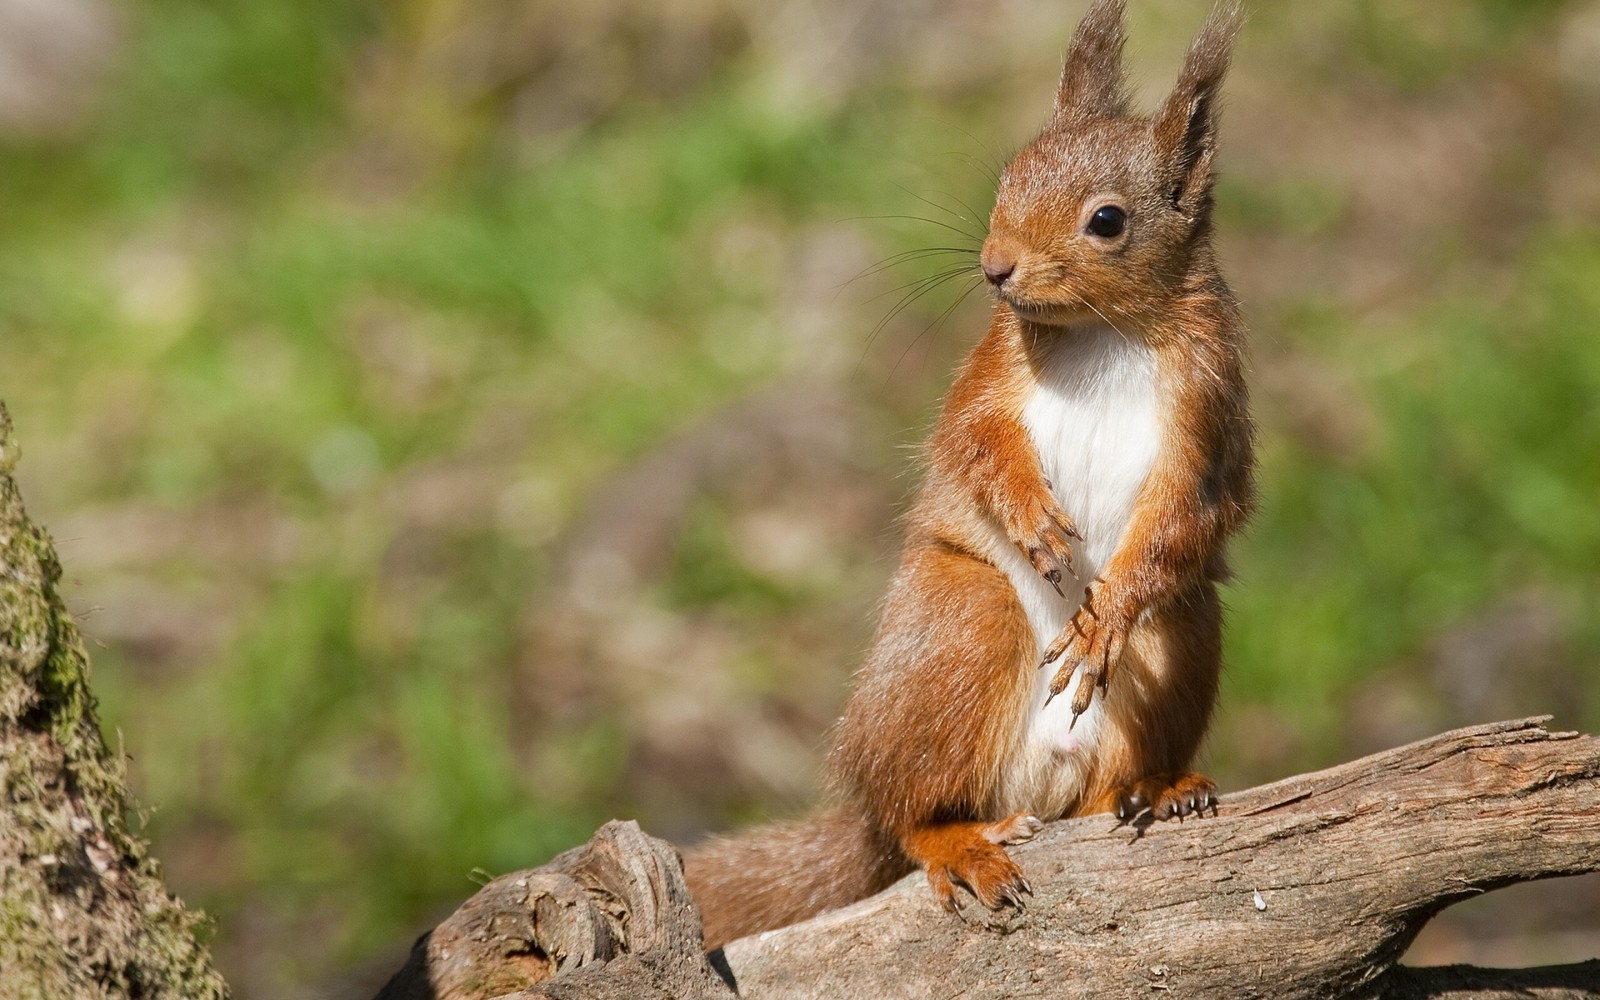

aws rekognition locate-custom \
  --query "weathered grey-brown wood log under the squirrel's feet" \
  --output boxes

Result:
[382,718,1600,1000]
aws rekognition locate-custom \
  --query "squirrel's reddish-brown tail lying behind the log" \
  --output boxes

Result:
[683,806,914,950]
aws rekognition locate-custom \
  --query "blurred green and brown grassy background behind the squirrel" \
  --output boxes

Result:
[0,0,1600,998]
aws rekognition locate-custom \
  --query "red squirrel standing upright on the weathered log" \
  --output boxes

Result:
[685,0,1254,949]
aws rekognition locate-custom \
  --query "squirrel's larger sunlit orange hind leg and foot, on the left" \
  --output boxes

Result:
[830,538,1038,907]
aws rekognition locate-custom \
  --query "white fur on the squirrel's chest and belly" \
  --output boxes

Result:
[992,326,1165,816]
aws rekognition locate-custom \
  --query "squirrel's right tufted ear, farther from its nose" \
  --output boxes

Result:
[1155,0,1245,216]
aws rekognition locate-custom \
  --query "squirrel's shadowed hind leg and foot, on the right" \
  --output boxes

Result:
[1080,581,1222,821]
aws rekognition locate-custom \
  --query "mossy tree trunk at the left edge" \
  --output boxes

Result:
[0,405,227,1000]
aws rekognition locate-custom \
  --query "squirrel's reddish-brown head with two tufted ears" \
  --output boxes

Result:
[982,0,1242,325]
